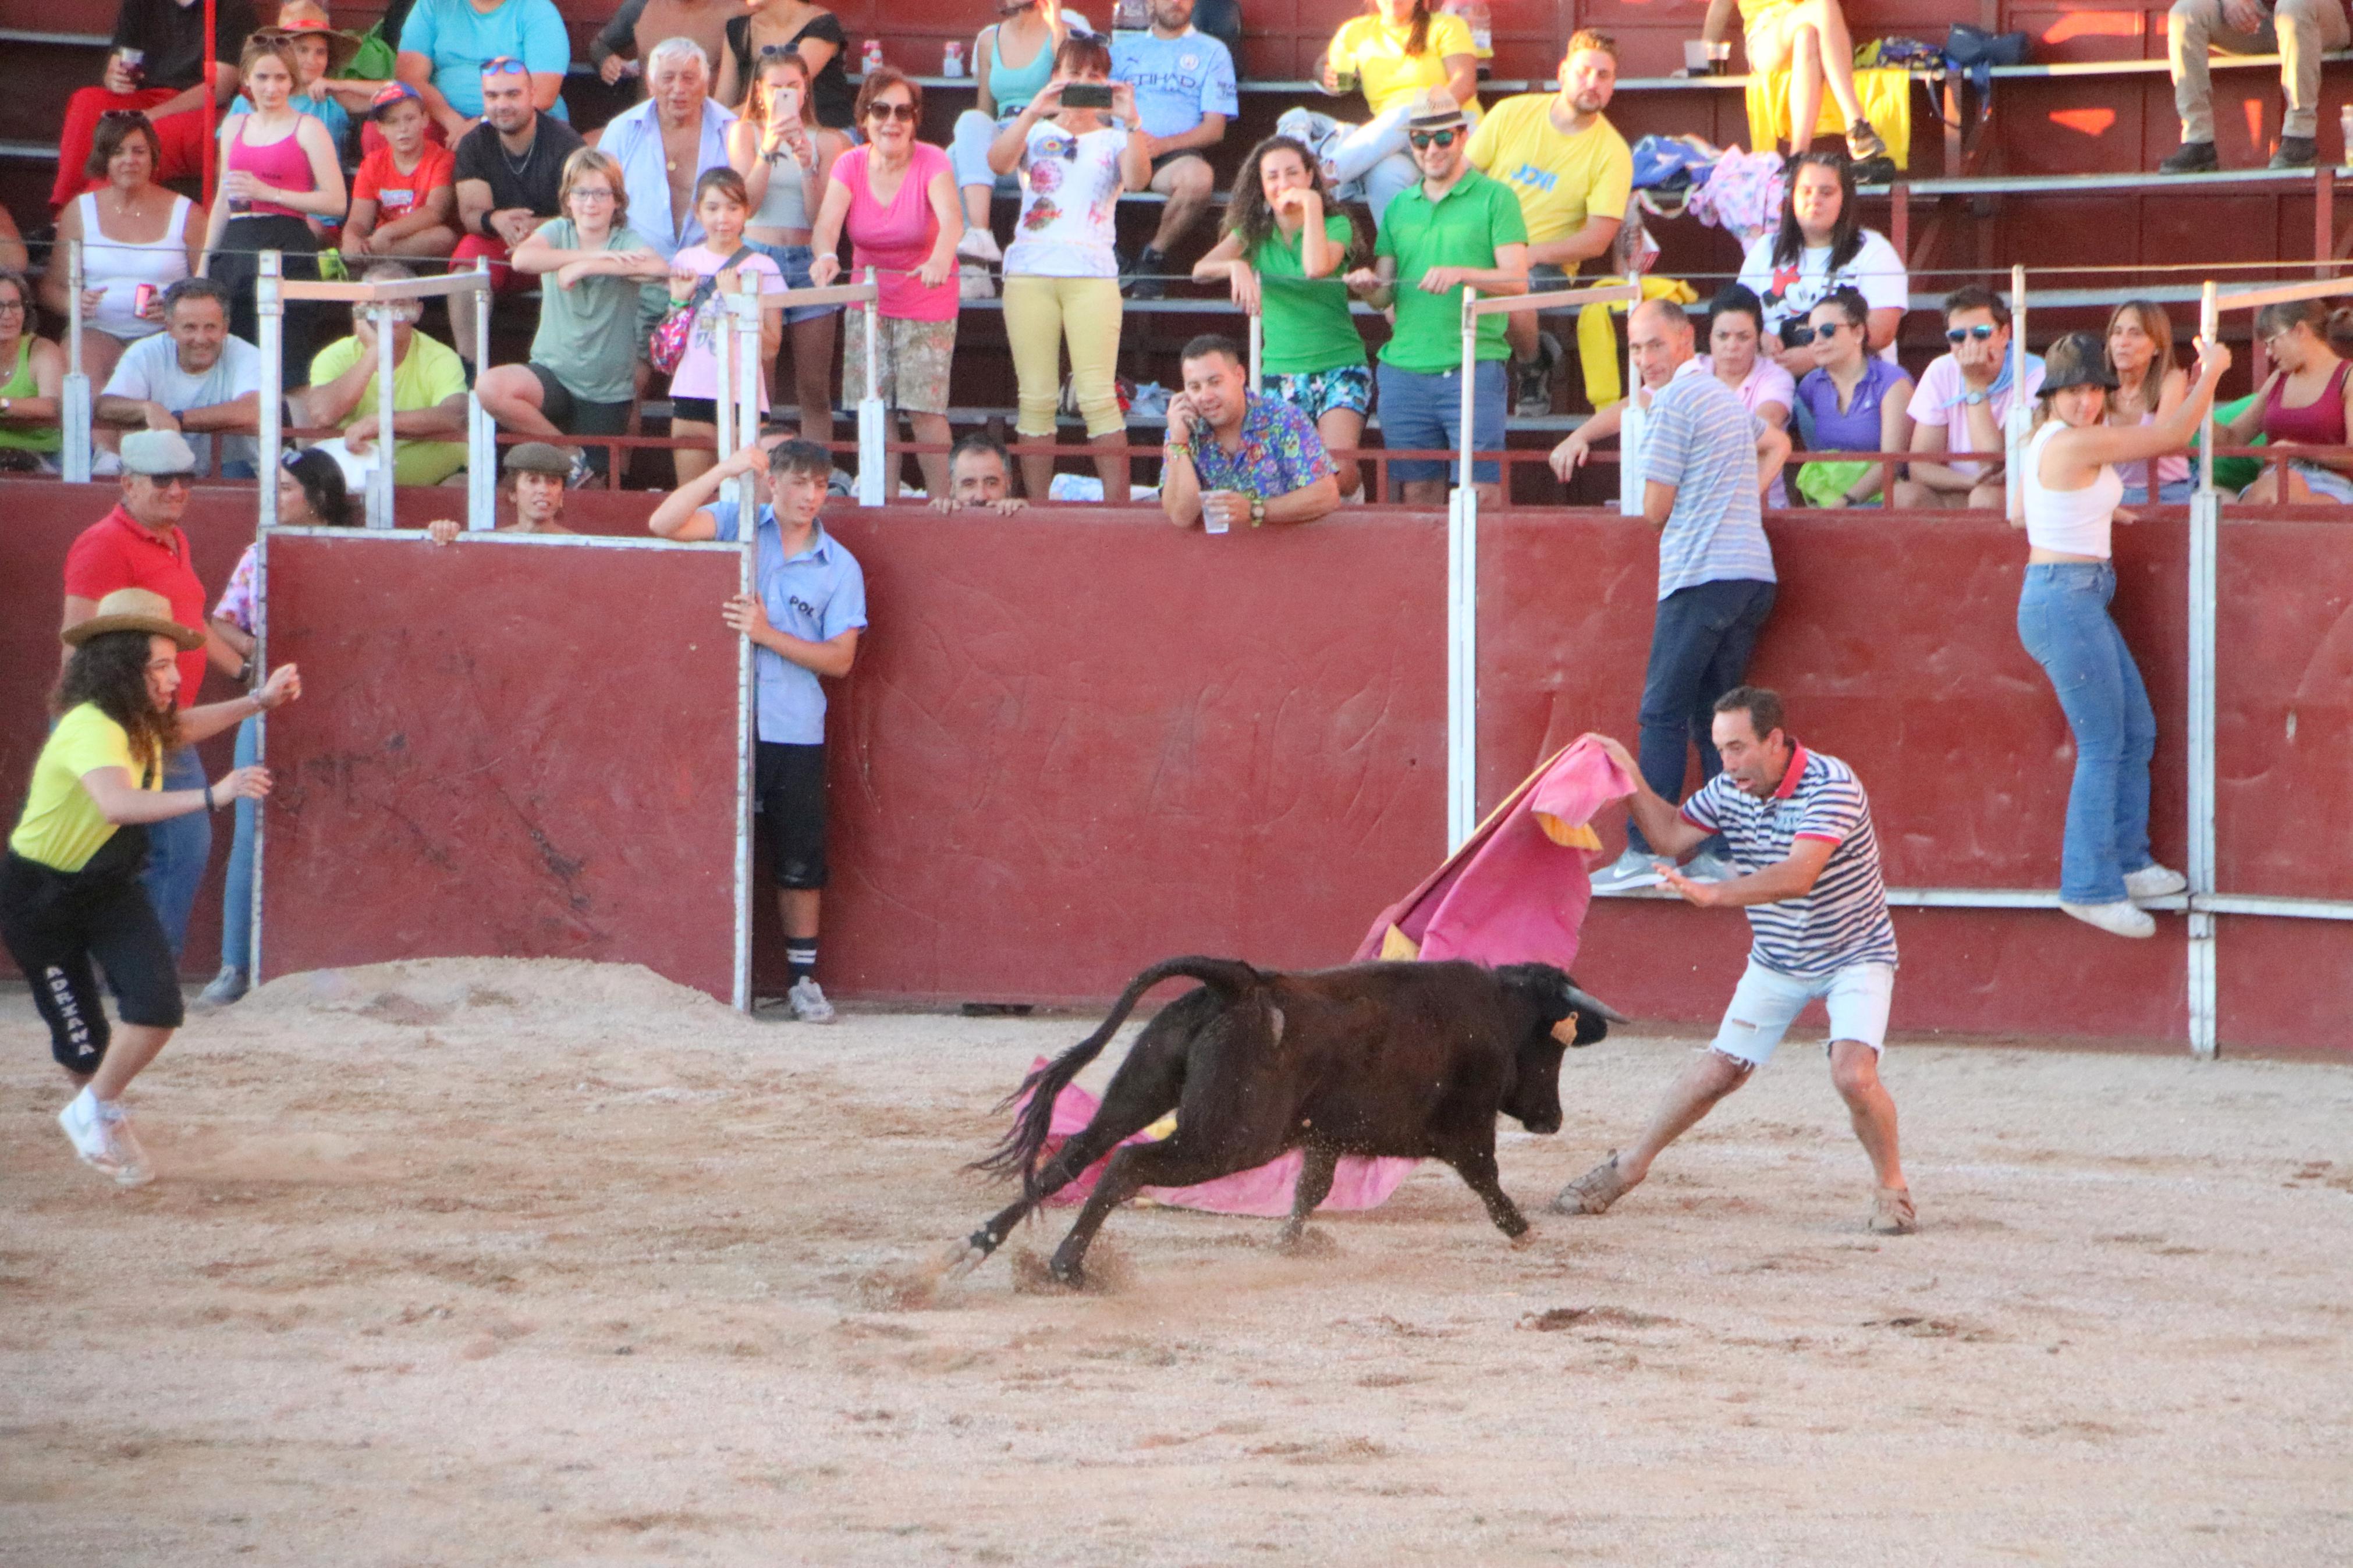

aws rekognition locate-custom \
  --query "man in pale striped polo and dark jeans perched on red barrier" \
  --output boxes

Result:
[1593,298,1788,893]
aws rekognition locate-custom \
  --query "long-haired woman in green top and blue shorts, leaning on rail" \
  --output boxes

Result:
[1193,136,1372,496]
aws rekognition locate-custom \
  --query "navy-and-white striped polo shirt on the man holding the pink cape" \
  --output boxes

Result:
[1683,743,1897,978]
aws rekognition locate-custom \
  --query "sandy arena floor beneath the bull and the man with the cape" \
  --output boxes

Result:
[0,962,2353,1568]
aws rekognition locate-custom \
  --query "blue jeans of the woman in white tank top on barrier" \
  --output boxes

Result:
[2019,562,2157,903]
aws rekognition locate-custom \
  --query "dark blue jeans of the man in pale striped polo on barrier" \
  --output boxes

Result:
[1626,581,1774,854]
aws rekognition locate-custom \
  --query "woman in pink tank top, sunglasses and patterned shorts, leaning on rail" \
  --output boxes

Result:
[810,66,965,496]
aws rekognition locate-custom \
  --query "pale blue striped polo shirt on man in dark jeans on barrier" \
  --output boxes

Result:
[1642,360,1774,599]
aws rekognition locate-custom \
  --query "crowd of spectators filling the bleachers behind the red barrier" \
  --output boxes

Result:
[0,0,2344,510]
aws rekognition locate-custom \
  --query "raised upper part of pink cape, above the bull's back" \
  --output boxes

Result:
[1355,741,1635,969]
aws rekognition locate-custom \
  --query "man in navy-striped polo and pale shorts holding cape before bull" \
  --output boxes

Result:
[1553,687,1915,1234]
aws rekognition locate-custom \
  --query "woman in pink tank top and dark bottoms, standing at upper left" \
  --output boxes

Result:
[203,33,343,388]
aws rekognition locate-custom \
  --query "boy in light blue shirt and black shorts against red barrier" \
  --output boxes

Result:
[647,442,866,1023]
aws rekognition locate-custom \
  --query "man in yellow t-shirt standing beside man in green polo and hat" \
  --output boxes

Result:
[1471,31,1633,416]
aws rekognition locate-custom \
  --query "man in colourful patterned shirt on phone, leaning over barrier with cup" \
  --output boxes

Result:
[1160,334,1339,534]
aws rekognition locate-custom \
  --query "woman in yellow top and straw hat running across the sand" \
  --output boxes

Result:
[0,588,301,1187]
